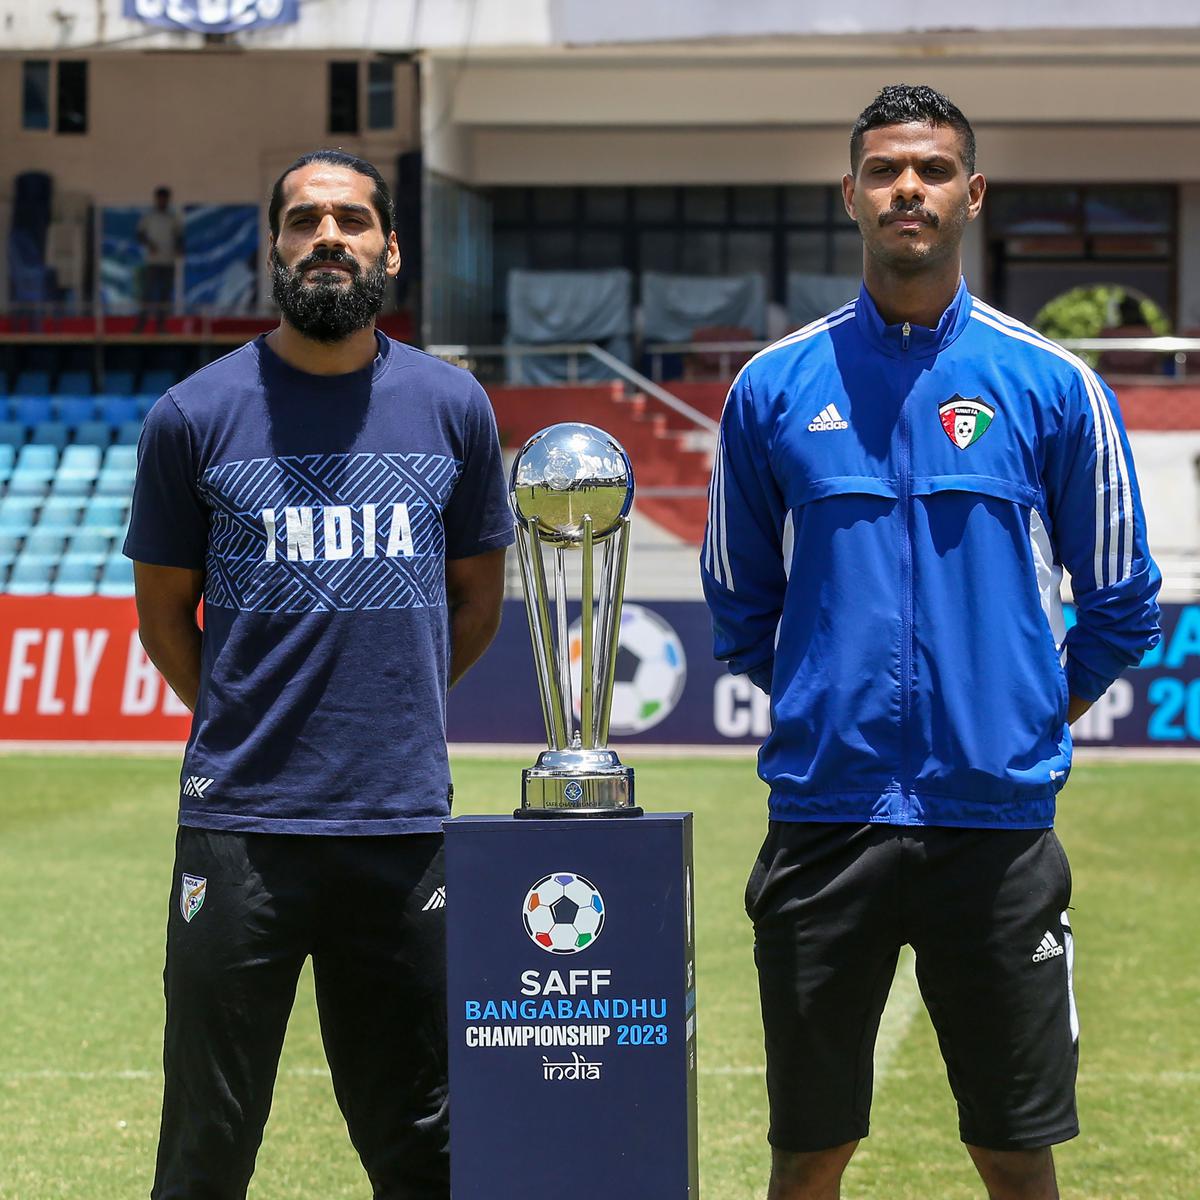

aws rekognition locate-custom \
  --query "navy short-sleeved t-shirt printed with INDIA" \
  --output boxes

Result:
[125,334,512,834]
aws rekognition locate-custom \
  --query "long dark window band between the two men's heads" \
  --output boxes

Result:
[490,185,863,329]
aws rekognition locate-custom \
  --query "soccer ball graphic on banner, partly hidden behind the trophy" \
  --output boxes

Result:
[570,604,688,736]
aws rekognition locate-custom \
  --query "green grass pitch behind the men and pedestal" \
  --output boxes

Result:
[0,752,1200,1200]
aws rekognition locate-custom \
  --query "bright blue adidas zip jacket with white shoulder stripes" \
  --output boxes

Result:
[701,283,1160,828]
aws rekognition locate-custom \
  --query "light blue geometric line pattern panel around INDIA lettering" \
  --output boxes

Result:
[200,454,460,613]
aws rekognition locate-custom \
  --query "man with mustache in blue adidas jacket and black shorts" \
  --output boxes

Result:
[702,85,1159,1200]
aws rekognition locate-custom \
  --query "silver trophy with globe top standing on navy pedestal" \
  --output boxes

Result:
[509,422,642,817]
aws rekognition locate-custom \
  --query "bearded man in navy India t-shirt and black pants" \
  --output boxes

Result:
[125,151,512,1200]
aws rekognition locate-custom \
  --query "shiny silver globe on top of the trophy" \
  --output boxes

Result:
[509,421,634,547]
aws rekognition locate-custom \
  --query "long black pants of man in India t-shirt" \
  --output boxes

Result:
[151,827,450,1200]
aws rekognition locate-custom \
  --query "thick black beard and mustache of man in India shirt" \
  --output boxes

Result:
[271,250,388,344]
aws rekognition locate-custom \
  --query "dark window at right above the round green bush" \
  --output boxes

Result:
[983,184,1178,320]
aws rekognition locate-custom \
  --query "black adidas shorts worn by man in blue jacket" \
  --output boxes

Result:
[746,821,1079,1151]
